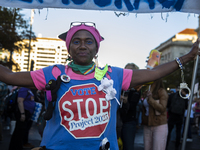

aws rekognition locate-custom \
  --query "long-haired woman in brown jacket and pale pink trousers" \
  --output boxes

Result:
[142,79,168,150]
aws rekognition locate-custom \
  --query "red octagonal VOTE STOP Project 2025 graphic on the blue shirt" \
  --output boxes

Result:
[59,83,111,138]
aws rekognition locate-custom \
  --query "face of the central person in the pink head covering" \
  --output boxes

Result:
[69,30,97,65]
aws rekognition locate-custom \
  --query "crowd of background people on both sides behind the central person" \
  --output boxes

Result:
[0,78,200,150]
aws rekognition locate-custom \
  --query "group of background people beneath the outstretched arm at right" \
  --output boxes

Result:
[117,79,200,150]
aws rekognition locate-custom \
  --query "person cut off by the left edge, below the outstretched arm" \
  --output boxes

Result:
[0,81,9,141]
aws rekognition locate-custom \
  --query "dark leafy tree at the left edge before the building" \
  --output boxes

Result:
[0,6,35,69]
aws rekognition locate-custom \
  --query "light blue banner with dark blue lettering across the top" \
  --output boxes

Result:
[0,0,200,14]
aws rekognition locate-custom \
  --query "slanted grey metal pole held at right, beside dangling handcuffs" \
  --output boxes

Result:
[181,15,200,150]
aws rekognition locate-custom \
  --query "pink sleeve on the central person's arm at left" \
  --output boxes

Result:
[31,69,46,90]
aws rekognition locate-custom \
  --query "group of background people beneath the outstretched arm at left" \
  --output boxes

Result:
[0,82,44,150]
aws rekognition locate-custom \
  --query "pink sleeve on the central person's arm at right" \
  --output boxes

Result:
[122,69,133,91]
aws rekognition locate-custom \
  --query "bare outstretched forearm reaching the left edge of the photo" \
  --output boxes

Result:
[0,65,35,87]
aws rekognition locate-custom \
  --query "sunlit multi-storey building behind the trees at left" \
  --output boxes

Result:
[13,37,68,71]
